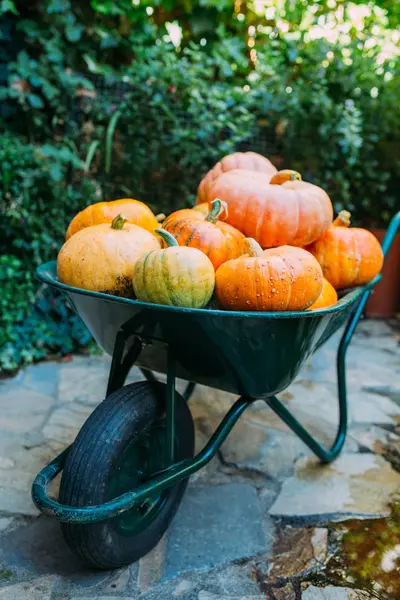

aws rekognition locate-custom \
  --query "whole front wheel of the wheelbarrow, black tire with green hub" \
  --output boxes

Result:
[60,382,194,569]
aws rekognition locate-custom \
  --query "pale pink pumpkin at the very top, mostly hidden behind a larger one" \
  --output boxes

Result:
[197,152,276,204]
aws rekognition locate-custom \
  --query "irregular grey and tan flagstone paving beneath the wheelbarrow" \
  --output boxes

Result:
[0,321,400,600]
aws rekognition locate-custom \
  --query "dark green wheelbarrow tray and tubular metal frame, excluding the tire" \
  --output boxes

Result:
[32,212,400,568]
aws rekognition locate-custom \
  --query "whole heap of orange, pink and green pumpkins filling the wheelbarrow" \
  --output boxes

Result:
[57,152,383,311]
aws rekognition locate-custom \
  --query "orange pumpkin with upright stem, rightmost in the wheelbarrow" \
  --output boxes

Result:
[307,210,383,290]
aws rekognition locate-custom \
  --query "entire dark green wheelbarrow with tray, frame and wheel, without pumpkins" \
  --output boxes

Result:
[32,213,400,568]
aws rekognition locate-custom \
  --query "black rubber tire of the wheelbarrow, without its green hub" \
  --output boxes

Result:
[59,381,194,569]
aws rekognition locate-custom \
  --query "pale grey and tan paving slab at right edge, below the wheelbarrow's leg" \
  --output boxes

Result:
[270,453,400,522]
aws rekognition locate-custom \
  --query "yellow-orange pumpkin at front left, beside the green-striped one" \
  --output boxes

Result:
[57,215,160,298]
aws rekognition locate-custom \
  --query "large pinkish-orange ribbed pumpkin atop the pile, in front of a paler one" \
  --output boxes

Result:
[202,169,333,248]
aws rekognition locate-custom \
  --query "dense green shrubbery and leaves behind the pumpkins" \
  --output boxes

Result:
[0,0,400,370]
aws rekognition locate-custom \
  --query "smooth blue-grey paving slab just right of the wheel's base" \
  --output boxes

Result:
[164,483,270,579]
